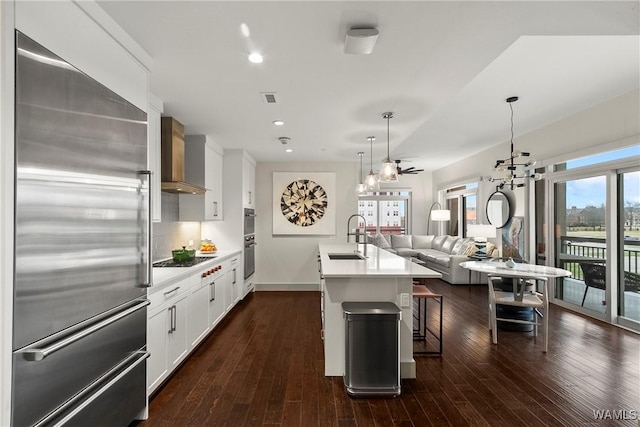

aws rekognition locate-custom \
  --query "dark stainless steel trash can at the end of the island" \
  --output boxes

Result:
[342,302,402,397]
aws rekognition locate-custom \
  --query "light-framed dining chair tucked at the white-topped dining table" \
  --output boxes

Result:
[489,275,549,353]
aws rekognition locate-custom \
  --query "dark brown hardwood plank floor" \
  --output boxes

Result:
[132,280,640,427]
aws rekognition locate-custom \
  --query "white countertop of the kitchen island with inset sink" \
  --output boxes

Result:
[319,243,442,278]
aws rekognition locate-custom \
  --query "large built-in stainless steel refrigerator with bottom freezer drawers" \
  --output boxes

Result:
[12,32,150,427]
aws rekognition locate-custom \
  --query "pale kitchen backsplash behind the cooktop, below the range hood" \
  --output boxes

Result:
[153,192,200,261]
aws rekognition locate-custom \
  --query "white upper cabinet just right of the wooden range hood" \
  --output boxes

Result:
[179,135,223,221]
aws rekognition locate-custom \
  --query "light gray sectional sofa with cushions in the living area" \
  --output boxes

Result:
[369,234,497,285]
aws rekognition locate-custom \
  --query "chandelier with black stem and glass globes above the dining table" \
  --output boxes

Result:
[489,96,542,190]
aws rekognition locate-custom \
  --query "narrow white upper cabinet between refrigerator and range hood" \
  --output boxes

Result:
[147,94,164,222]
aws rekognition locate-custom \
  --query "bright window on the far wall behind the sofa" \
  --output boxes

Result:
[358,190,411,234]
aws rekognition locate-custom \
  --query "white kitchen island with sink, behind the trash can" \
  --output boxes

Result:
[319,243,442,378]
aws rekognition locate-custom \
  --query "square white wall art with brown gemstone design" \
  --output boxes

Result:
[272,172,336,236]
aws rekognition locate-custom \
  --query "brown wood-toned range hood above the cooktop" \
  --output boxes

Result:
[161,117,206,194]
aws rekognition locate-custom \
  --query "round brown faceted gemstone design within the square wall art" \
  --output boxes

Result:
[280,179,327,227]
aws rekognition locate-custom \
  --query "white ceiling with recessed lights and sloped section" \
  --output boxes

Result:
[99,0,640,170]
